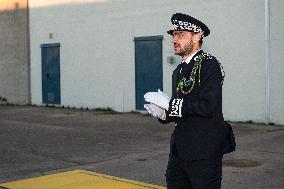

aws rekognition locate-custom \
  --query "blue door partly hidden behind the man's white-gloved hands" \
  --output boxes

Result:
[134,36,163,110]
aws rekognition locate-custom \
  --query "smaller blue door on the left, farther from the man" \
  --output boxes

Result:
[41,43,61,104]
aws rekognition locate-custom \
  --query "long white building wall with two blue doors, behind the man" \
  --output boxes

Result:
[29,0,284,124]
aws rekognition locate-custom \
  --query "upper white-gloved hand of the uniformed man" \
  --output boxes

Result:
[144,89,170,110]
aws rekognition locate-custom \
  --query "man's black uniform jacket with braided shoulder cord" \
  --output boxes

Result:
[159,50,228,160]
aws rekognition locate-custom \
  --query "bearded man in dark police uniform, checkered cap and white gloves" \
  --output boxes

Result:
[144,13,228,189]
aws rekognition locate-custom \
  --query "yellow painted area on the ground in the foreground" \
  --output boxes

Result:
[0,170,166,189]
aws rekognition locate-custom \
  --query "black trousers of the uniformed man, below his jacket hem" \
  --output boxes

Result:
[166,147,223,189]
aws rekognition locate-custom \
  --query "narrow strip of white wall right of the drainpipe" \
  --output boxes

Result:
[269,0,284,124]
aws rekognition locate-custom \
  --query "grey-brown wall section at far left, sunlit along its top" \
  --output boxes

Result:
[0,0,30,104]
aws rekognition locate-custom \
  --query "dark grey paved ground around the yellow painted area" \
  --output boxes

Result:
[0,105,284,189]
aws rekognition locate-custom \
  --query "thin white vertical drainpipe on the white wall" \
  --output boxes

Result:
[265,0,271,124]
